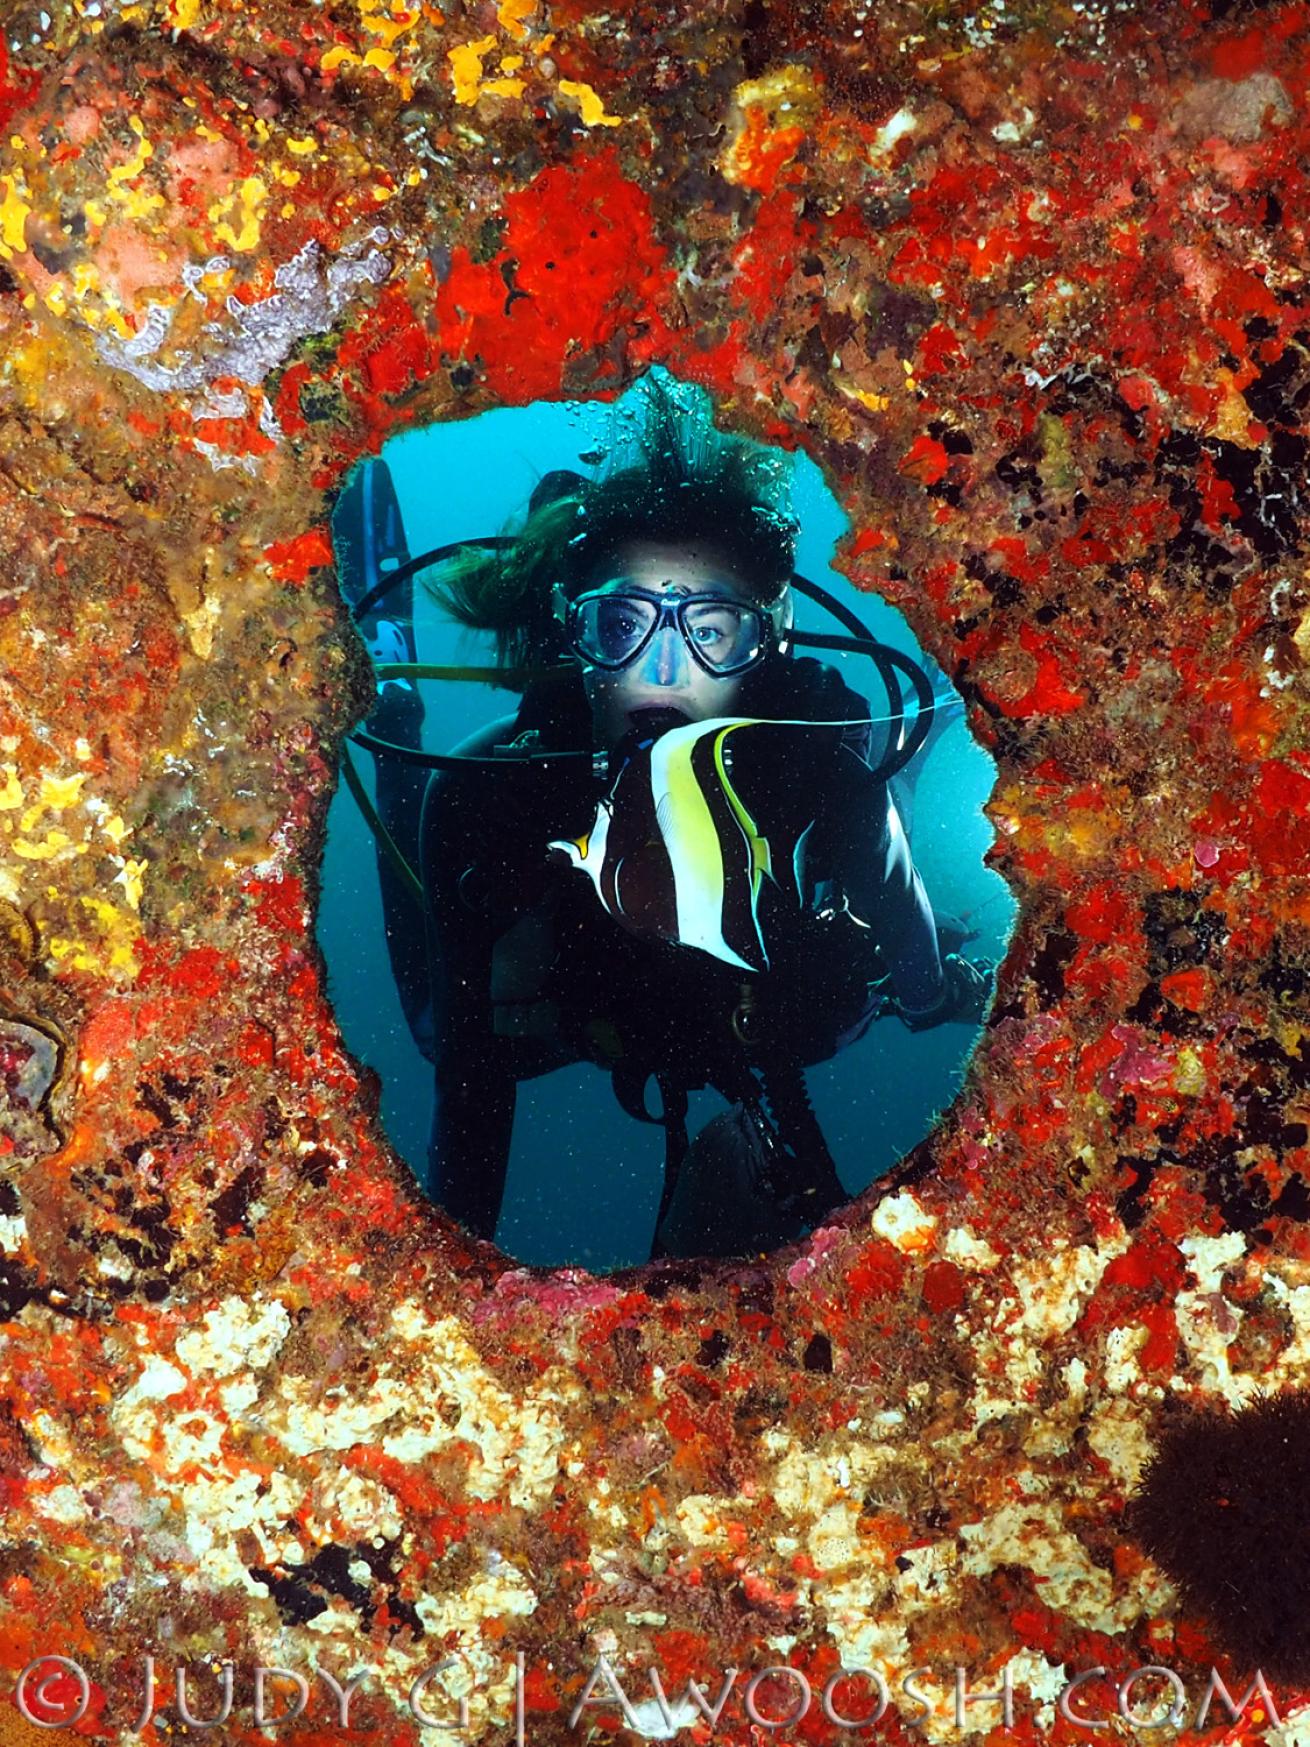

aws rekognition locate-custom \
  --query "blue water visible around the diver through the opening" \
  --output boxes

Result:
[318,379,1015,1270]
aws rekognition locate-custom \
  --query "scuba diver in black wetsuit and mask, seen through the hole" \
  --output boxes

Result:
[337,379,990,1256]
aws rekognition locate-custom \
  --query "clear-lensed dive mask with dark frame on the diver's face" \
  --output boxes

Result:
[564,585,777,680]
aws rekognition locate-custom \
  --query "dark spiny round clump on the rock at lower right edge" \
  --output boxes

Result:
[1130,1391,1310,1681]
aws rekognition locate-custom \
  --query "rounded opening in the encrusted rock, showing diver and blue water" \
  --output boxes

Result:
[318,370,1015,1272]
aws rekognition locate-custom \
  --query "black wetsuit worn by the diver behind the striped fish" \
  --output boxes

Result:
[405,657,941,1237]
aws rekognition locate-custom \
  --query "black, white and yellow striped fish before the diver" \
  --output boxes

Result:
[550,716,844,971]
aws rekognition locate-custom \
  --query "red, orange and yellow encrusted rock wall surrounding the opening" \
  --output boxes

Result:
[0,0,1310,1742]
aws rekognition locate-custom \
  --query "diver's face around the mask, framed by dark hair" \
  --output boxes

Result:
[583,540,749,746]
